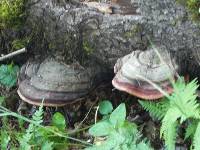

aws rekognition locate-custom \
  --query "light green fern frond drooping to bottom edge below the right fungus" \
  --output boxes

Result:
[160,107,181,150]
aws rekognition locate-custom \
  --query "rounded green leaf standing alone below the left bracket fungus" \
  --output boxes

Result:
[52,112,66,130]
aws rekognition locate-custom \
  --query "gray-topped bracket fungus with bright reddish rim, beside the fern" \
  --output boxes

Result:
[112,49,177,100]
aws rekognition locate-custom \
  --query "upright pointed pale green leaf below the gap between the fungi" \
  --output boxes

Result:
[109,103,126,126]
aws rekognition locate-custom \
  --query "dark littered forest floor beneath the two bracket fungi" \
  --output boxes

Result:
[1,78,188,150]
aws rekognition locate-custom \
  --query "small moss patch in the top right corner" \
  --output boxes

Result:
[177,0,200,23]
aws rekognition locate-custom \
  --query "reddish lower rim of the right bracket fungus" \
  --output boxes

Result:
[112,77,173,100]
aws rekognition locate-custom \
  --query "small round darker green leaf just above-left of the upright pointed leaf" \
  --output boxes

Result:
[99,100,113,115]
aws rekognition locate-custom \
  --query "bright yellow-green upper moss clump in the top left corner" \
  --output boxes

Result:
[0,0,27,29]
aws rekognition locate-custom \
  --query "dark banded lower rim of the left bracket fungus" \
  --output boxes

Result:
[17,80,87,107]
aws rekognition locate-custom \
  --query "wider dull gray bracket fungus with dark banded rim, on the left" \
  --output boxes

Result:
[17,58,103,106]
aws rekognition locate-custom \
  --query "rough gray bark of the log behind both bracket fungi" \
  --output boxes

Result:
[9,0,200,77]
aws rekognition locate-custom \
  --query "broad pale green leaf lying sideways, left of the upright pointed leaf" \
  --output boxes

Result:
[89,121,113,136]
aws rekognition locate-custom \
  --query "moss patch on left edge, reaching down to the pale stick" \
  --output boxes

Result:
[0,0,29,53]
